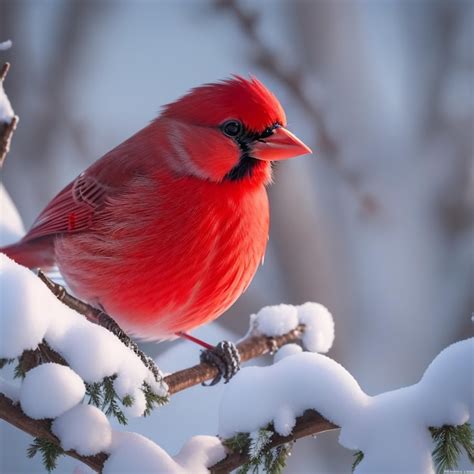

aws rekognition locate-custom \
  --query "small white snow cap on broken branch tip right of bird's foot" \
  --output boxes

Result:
[251,302,334,352]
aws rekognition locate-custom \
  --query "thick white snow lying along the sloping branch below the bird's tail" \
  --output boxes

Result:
[0,254,167,415]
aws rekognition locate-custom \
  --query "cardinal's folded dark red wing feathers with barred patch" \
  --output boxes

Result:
[23,171,110,241]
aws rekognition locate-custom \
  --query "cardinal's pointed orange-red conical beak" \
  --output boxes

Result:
[252,127,312,161]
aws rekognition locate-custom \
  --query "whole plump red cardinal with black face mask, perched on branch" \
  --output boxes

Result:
[0,77,311,378]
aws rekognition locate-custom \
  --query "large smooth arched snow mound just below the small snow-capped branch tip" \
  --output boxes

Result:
[219,352,369,438]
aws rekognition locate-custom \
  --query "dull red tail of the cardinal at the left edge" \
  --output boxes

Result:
[0,236,55,268]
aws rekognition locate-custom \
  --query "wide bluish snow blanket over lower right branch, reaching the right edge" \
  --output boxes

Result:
[219,338,474,473]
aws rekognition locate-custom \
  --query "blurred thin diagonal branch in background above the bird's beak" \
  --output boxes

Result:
[214,0,380,214]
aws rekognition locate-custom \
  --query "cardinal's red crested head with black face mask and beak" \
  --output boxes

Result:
[160,76,311,182]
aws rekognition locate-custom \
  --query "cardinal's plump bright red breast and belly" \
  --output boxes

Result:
[57,172,269,339]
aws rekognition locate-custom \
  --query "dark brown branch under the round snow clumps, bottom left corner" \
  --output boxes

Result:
[0,393,107,472]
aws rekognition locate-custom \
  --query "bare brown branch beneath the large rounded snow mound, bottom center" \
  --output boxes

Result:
[209,410,339,474]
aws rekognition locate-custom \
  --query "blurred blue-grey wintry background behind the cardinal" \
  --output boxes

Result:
[0,0,474,474]
